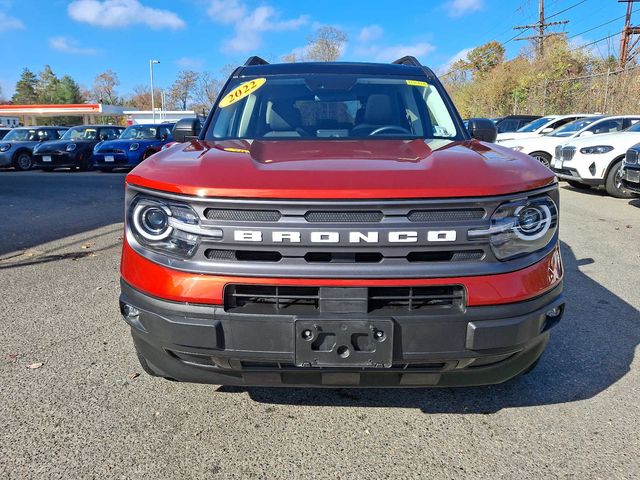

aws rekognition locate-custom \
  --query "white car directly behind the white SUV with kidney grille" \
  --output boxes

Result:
[500,115,640,167]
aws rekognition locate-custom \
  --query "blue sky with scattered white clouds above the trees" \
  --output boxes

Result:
[0,0,640,97]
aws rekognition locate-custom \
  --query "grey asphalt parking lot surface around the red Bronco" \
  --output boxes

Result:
[0,170,640,479]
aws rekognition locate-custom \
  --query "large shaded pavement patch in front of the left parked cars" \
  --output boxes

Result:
[0,171,125,256]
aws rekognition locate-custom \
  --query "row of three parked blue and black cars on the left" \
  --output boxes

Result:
[0,123,174,171]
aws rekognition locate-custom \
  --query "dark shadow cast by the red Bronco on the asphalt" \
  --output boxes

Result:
[235,243,640,414]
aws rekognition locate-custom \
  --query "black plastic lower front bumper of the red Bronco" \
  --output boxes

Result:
[120,282,564,387]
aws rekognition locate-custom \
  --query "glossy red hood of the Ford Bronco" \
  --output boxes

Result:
[127,140,555,199]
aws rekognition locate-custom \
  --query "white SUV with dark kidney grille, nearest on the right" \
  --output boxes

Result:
[551,122,640,198]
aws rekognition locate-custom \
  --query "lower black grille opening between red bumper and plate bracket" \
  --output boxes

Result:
[224,284,465,315]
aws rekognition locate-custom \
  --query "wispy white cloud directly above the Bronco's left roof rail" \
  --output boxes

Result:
[207,0,309,53]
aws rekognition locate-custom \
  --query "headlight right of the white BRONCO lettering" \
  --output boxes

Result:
[469,195,558,260]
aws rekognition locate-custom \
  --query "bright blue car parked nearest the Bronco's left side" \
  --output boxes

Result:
[93,123,175,172]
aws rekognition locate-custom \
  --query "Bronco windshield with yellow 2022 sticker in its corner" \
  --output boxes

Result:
[206,74,464,140]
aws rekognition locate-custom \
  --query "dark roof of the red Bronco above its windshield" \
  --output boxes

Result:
[234,62,435,77]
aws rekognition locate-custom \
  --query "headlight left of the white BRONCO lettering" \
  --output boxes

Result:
[127,196,222,258]
